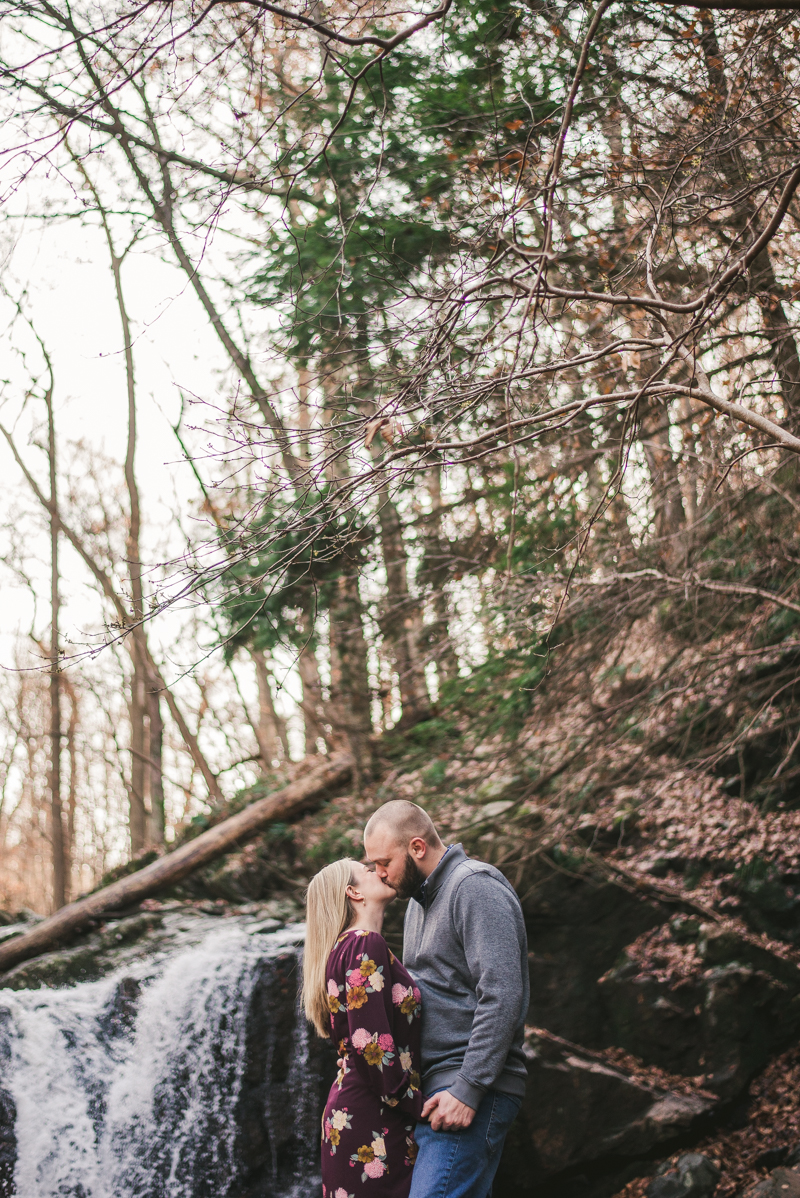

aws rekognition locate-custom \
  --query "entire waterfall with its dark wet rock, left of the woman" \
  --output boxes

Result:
[0,920,330,1198]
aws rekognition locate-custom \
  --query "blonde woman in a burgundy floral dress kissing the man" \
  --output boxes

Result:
[303,859,423,1198]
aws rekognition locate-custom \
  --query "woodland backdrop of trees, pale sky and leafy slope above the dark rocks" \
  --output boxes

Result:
[0,0,800,913]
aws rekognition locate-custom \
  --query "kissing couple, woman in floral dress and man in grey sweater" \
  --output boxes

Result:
[303,799,529,1198]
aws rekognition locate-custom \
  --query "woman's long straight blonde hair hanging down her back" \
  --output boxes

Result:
[301,857,356,1040]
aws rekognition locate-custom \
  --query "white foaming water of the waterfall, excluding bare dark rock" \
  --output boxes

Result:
[0,921,316,1198]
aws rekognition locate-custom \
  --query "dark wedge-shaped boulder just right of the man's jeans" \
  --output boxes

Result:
[497,1031,715,1198]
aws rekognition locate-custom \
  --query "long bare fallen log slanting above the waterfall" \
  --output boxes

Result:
[0,752,353,973]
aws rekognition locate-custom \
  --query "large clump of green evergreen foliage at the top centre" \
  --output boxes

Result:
[250,0,556,359]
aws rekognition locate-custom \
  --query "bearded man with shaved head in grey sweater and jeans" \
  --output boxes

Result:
[364,799,529,1198]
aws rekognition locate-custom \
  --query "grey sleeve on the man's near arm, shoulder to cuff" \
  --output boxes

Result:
[449,873,527,1111]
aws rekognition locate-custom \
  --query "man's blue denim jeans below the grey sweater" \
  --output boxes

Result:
[410,1090,522,1198]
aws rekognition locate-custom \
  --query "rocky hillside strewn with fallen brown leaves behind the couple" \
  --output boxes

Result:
[6,580,800,1198]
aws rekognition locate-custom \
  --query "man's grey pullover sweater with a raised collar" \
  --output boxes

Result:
[402,845,529,1111]
